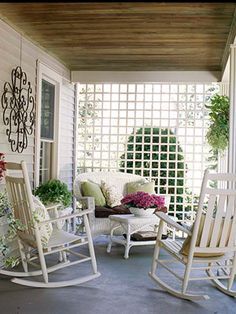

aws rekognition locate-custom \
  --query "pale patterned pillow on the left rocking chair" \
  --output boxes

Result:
[32,195,53,247]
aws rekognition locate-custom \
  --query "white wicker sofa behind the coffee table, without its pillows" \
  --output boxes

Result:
[73,171,169,237]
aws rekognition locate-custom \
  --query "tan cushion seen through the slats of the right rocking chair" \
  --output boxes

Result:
[180,213,228,257]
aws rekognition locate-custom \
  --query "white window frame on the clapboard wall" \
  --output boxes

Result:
[35,60,62,186]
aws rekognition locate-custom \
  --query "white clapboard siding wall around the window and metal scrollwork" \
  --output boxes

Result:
[0,21,75,188]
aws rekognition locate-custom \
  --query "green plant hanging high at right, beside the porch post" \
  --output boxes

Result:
[205,94,229,152]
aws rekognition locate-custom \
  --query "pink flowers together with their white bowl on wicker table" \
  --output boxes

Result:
[121,192,167,216]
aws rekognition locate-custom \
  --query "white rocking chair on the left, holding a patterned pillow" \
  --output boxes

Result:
[0,161,100,288]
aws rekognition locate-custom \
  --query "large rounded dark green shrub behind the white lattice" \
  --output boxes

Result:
[120,127,188,219]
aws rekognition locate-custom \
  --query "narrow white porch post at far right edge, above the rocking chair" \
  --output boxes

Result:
[229,45,236,173]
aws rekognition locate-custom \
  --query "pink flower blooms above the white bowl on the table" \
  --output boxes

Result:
[121,192,165,209]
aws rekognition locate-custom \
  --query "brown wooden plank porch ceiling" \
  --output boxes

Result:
[0,2,236,77]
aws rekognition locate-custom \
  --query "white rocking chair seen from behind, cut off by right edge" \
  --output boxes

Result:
[149,170,236,300]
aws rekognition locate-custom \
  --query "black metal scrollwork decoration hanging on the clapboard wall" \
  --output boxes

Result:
[1,66,35,153]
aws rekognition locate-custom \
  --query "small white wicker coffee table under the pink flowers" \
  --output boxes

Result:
[107,214,159,259]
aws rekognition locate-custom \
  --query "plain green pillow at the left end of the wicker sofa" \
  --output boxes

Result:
[81,181,106,206]
